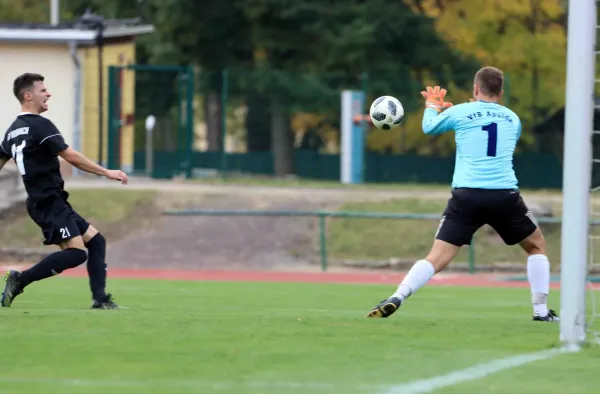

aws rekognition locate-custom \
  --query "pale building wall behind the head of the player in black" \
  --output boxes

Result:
[0,42,75,144]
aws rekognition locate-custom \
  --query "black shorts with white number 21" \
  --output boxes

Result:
[27,192,90,245]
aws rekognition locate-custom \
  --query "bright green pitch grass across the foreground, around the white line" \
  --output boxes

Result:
[0,277,600,394]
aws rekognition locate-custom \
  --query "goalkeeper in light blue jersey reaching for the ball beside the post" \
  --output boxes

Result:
[367,67,559,321]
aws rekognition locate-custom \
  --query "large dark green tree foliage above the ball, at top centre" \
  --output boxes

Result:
[232,0,477,168]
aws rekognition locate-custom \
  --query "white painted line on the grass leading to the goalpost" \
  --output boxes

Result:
[379,349,568,394]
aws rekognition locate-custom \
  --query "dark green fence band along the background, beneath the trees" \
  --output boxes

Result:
[134,149,562,189]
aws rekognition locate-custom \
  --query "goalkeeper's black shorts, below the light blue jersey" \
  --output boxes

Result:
[435,188,538,246]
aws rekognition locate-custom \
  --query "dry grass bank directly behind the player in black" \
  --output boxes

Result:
[0,189,156,248]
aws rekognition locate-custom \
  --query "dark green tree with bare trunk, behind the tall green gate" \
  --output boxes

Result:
[63,0,251,151]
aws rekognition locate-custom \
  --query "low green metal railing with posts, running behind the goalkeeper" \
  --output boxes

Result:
[163,209,600,274]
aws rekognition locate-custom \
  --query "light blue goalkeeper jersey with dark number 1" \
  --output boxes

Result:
[422,101,521,189]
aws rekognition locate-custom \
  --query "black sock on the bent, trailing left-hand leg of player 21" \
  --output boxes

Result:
[19,248,87,287]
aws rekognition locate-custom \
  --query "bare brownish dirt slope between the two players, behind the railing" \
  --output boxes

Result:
[107,193,339,269]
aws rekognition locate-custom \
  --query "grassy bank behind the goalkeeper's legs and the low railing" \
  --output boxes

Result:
[328,198,600,266]
